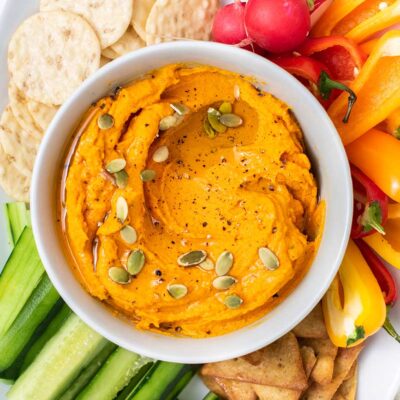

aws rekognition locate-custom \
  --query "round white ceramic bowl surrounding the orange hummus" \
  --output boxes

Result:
[31,42,353,363]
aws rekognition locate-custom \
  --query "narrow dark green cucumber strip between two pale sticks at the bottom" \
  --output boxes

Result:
[58,342,117,400]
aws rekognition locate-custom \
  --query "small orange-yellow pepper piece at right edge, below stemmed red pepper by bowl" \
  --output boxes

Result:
[363,227,400,269]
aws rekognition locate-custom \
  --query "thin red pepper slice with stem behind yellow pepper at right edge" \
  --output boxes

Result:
[355,240,400,342]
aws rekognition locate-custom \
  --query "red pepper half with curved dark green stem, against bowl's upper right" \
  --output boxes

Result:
[270,56,357,122]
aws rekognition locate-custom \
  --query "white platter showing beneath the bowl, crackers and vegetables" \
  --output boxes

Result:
[0,0,400,400]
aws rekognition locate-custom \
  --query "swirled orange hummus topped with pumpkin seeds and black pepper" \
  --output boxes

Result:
[61,65,323,337]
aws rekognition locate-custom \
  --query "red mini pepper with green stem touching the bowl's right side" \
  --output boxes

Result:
[351,165,389,239]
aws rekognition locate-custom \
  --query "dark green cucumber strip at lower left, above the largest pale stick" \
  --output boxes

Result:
[21,303,72,374]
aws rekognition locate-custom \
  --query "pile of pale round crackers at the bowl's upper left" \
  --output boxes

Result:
[0,0,219,202]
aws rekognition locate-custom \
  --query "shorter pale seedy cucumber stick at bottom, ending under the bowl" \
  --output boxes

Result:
[77,347,151,400]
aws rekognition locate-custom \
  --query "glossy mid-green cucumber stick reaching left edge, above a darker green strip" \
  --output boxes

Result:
[0,275,60,371]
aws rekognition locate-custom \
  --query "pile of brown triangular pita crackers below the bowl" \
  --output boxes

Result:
[201,305,362,400]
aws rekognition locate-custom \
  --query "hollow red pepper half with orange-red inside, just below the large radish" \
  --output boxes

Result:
[297,35,367,81]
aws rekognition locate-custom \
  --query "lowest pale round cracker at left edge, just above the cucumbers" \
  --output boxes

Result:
[0,144,31,203]
